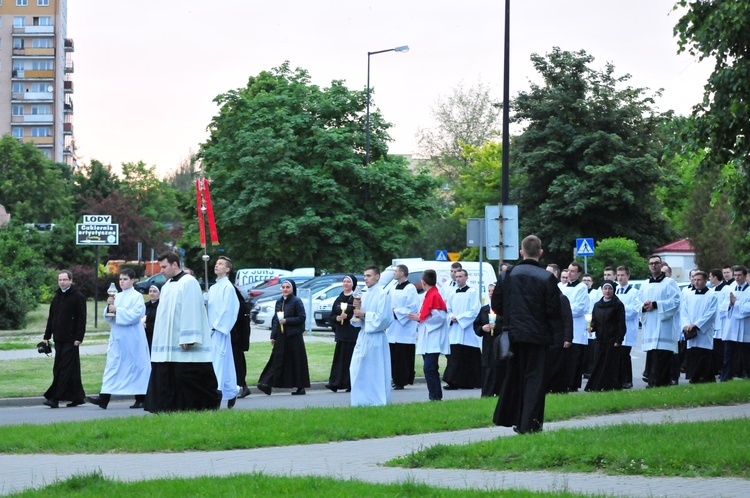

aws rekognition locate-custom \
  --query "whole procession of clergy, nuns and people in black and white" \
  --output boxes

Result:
[38,244,750,433]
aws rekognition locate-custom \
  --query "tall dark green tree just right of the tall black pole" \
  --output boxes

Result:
[511,47,672,261]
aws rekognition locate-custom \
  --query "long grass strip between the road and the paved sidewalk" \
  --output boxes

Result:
[0,381,750,453]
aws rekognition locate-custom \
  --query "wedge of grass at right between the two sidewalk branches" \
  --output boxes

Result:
[388,419,750,480]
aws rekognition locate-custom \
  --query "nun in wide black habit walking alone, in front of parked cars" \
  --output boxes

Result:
[258,280,310,395]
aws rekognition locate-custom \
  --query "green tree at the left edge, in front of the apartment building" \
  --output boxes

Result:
[0,135,71,223]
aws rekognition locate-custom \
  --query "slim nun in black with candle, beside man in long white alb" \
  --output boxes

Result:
[325,274,359,392]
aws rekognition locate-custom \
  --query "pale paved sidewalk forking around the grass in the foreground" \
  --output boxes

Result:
[0,404,750,497]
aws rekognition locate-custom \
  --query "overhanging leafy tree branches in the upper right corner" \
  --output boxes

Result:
[674,0,750,253]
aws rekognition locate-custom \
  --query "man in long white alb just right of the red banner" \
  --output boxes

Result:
[208,256,240,408]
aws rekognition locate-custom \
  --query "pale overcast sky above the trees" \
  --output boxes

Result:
[68,0,711,176]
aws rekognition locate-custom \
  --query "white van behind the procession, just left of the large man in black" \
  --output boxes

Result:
[380,258,497,304]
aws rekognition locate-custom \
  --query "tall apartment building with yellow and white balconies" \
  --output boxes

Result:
[0,0,75,166]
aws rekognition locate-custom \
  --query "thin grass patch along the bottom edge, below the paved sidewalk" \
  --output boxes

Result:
[2,474,598,498]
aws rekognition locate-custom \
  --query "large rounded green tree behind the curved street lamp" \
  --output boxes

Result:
[200,63,434,270]
